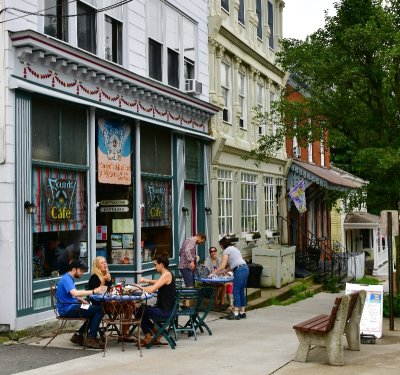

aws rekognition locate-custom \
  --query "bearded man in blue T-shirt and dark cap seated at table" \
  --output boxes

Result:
[57,260,107,349]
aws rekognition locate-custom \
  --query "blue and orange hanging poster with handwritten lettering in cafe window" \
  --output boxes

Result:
[97,119,131,185]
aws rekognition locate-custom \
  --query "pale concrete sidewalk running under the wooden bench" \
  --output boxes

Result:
[8,293,400,375]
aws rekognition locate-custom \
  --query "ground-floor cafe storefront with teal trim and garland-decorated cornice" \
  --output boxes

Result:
[0,1,217,329]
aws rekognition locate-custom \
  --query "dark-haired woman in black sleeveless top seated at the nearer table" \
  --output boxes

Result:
[139,255,176,346]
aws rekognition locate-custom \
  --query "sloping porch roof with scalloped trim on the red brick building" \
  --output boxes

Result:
[289,160,358,190]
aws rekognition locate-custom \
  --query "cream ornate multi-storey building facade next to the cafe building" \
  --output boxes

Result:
[208,0,288,258]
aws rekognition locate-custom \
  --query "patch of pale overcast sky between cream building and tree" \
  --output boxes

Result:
[283,0,335,39]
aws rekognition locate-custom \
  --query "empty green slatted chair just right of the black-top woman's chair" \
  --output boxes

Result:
[172,288,199,340]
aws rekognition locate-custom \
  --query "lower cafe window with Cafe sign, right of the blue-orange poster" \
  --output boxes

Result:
[141,178,173,262]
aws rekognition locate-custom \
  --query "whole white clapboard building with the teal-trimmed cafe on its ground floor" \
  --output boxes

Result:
[0,0,218,330]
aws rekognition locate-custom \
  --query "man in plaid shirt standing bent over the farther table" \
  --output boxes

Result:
[178,233,206,288]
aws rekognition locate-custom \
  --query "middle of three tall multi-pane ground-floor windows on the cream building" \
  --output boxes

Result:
[240,173,258,233]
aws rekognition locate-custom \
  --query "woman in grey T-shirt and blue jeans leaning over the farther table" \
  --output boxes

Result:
[211,237,249,320]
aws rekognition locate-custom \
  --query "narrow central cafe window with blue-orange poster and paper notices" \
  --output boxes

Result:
[96,118,135,264]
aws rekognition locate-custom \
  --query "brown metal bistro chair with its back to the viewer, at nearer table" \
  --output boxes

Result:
[101,285,147,357]
